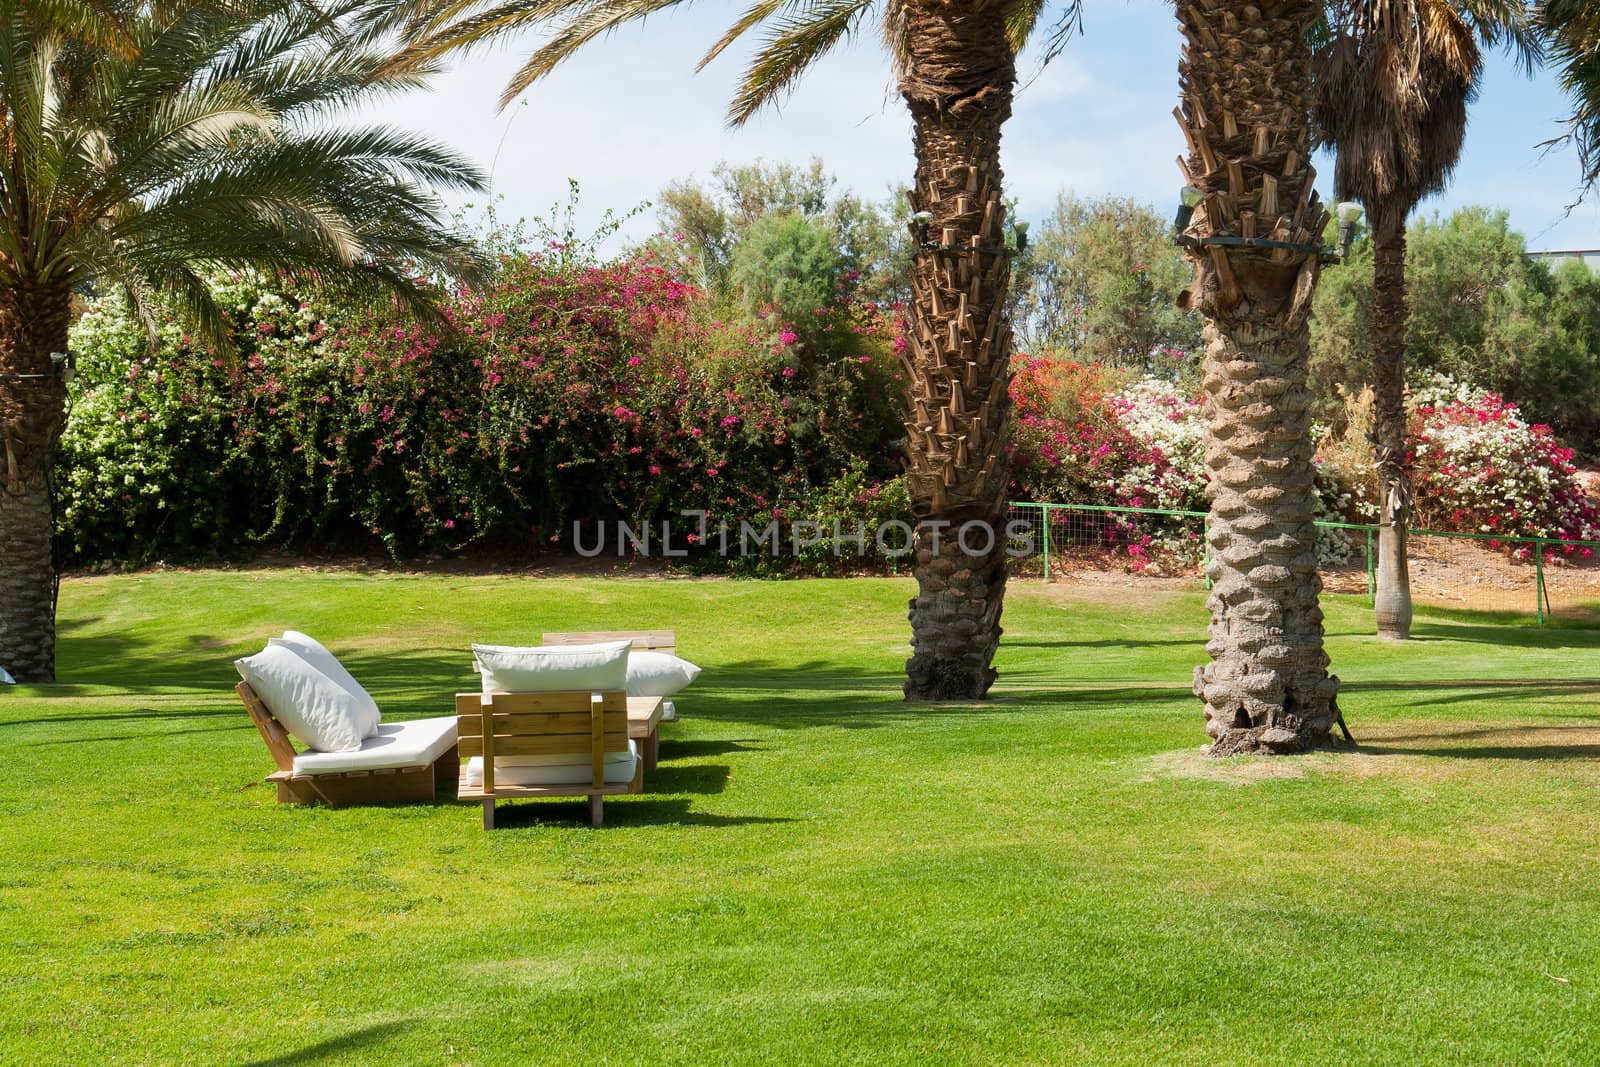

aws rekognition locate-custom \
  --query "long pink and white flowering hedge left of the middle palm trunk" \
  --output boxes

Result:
[61,248,904,572]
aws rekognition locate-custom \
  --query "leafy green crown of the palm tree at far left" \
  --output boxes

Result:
[0,0,486,350]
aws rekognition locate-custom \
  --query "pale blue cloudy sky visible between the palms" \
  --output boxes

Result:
[360,0,1600,250]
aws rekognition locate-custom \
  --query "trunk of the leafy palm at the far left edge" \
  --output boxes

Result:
[0,286,70,681]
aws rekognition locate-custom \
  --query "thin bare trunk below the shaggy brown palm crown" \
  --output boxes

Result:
[1373,213,1411,640]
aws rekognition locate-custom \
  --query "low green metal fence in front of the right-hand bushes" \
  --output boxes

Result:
[1010,501,1600,622]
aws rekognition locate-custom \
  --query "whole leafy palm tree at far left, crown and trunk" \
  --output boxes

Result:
[0,0,482,681]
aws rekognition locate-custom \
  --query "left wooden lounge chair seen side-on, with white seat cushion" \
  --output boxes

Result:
[234,681,458,808]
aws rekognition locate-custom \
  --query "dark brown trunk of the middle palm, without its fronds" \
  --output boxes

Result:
[901,0,1016,701]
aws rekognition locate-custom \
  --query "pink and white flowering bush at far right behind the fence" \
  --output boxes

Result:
[1410,384,1600,558]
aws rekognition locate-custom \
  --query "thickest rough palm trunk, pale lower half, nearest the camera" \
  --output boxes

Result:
[1178,0,1339,755]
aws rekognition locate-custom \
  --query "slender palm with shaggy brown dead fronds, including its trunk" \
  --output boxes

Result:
[1314,0,1538,638]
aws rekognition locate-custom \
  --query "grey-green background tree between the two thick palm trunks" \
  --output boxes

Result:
[1018,194,1200,374]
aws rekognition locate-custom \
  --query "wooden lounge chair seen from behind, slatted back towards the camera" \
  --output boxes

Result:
[456,691,645,830]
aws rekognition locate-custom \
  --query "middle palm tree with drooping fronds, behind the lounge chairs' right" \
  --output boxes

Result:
[373,0,1078,701]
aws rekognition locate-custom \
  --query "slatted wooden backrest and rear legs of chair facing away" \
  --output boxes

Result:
[456,689,627,793]
